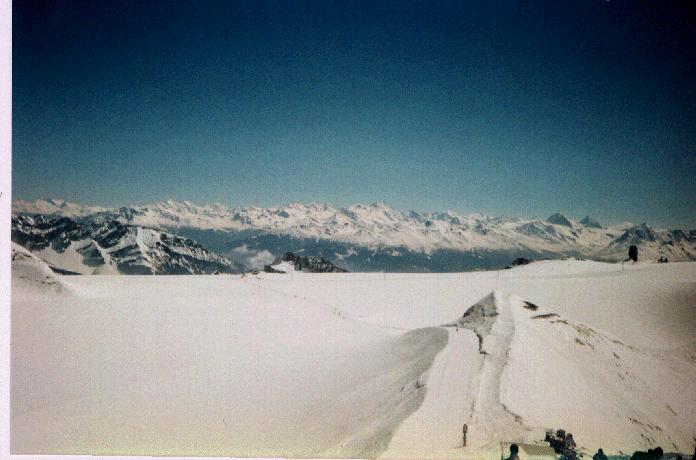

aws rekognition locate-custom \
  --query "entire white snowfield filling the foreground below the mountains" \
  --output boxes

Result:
[11,260,696,458]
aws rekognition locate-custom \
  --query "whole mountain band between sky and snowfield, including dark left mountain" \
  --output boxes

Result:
[12,200,696,274]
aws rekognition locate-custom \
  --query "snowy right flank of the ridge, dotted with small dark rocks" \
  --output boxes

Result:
[501,294,696,452]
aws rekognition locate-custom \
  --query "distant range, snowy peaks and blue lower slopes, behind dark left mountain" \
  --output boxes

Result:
[13,200,696,272]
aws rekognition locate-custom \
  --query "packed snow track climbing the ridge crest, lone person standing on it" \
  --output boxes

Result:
[383,291,530,459]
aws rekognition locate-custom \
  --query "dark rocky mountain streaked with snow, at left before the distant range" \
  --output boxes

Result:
[12,215,244,275]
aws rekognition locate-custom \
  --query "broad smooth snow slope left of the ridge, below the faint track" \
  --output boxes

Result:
[11,274,447,458]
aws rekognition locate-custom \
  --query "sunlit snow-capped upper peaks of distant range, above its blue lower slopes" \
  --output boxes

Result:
[13,200,696,260]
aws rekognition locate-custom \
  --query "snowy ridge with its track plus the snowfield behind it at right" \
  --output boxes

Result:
[245,260,696,459]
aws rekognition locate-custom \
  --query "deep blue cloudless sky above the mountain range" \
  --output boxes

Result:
[13,0,696,227]
